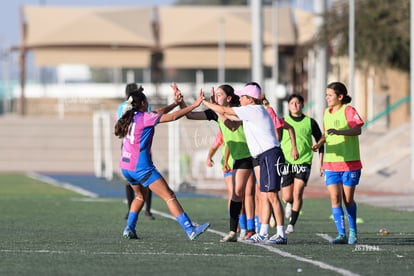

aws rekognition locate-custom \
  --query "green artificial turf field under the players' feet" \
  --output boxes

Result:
[0,175,414,275]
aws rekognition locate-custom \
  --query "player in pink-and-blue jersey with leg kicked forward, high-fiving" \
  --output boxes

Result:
[115,87,210,240]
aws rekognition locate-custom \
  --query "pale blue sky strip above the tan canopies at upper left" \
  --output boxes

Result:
[0,0,174,48]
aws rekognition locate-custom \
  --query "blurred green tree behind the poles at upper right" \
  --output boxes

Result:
[319,0,410,72]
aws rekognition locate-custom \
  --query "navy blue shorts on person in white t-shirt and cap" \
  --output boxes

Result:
[258,147,285,192]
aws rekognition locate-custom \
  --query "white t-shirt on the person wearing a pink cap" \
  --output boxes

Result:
[233,105,280,157]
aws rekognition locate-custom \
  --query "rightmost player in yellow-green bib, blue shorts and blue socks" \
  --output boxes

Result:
[312,82,364,244]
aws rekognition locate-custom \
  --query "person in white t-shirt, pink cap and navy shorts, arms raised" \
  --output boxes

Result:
[203,82,287,244]
